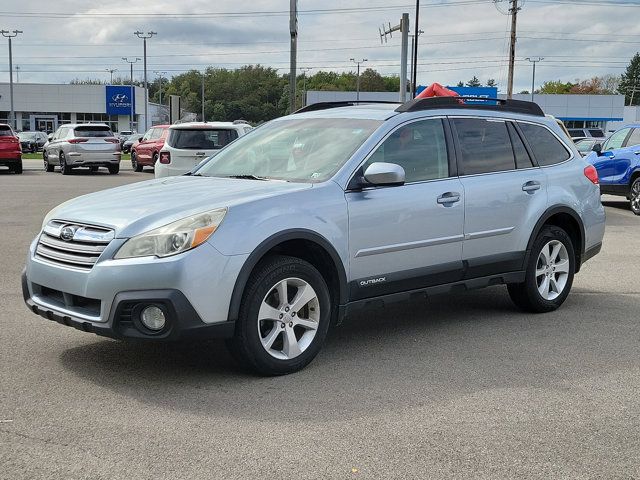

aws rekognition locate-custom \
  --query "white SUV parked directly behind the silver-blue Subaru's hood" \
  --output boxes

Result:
[155,121,252,178]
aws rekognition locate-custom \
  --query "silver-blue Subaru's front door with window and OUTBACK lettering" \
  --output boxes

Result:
[345,118,464,300]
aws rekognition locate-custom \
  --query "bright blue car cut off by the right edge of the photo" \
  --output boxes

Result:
[585,125,640,215]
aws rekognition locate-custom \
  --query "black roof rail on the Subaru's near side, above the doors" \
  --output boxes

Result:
[396,96,544,117]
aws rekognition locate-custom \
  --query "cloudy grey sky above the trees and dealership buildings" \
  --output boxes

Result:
[0,0,640,92]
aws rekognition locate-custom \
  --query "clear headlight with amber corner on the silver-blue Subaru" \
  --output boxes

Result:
[114,208,227,259]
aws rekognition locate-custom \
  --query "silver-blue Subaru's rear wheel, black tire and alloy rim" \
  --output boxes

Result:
[507,225,576,313]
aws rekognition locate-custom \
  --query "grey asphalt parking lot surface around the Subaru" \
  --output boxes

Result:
[0,160,640,479]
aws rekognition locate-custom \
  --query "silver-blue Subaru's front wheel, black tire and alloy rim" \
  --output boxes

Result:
[227,256,332,375]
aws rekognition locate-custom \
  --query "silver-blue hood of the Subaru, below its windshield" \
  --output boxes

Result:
[44,176,312,238]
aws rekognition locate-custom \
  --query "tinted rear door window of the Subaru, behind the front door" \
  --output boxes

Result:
[453,118,516,175]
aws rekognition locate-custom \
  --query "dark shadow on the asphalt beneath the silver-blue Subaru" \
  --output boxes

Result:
[60,287,624,423]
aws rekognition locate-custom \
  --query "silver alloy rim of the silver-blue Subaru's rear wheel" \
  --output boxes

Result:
[536,240,569,300]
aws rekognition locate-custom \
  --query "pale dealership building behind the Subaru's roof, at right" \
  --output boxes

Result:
[306,87,626,132]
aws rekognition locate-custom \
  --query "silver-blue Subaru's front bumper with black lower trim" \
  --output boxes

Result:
[23,238,246,340]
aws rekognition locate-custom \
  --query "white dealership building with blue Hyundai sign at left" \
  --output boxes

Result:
[0,83,168,133]
